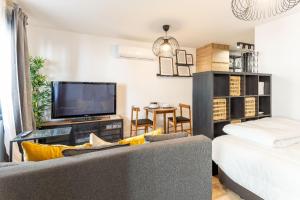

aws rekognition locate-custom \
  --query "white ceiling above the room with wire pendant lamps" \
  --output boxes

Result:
[17,0,300,47]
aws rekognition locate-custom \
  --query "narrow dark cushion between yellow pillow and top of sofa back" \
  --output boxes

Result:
[62,144,129,157]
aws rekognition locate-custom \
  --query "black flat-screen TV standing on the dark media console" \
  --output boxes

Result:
[52,81,116,118]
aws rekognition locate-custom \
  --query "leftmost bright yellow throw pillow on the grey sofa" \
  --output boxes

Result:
[22,141,92,161]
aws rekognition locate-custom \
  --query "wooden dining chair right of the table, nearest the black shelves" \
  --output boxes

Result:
[168,103,193,135]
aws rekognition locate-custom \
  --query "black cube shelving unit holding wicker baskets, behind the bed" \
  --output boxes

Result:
[193,72,272,139]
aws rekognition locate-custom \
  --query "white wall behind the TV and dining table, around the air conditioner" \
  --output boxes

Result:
[28,26,195,136]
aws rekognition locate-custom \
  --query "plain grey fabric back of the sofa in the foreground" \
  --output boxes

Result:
[0,136,212,200]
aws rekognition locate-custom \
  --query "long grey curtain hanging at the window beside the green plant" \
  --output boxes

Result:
[8,4,35,134]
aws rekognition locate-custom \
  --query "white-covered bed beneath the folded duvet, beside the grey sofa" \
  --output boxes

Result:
[212,118,300,200]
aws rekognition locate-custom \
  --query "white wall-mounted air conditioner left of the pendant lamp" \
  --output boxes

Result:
[117,45,156,61]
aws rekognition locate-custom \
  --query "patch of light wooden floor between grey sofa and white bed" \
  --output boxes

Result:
[212,177,241,200]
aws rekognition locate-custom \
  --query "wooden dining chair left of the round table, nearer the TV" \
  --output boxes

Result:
[130,106,153,136]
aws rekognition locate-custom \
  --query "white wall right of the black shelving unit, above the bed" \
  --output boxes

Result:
[255,13,300,119]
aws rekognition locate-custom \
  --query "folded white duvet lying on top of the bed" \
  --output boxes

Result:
[223,117,300,147]
